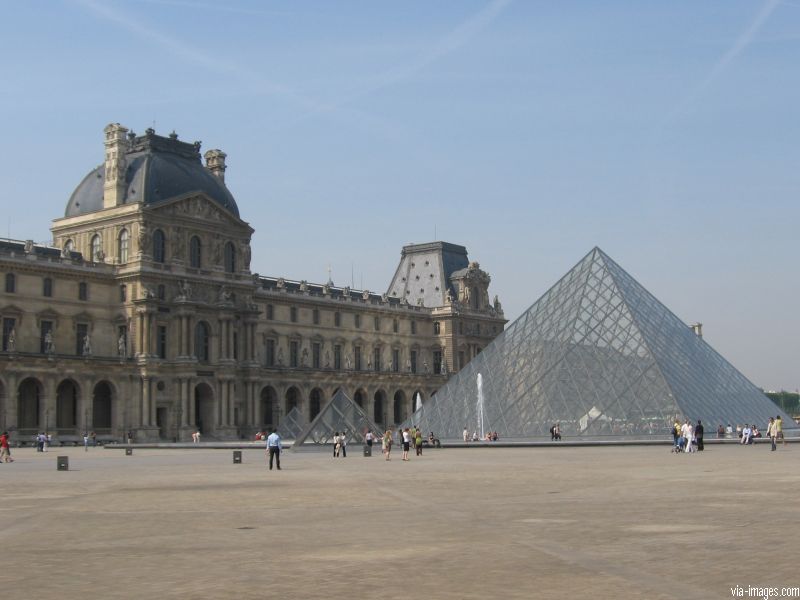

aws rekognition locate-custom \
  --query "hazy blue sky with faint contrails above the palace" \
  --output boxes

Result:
[0,0,800,390]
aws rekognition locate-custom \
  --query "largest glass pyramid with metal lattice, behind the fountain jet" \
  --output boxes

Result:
[404,248,794,440]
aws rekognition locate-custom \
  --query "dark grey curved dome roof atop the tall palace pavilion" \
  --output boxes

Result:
[64,129,239,217]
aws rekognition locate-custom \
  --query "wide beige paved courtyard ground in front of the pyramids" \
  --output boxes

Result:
[0,444,800,600]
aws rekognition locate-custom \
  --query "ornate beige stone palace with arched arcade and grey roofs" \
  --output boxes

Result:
[0,124,506,442]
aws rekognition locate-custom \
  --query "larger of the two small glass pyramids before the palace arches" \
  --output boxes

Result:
[292,390,381,448]
